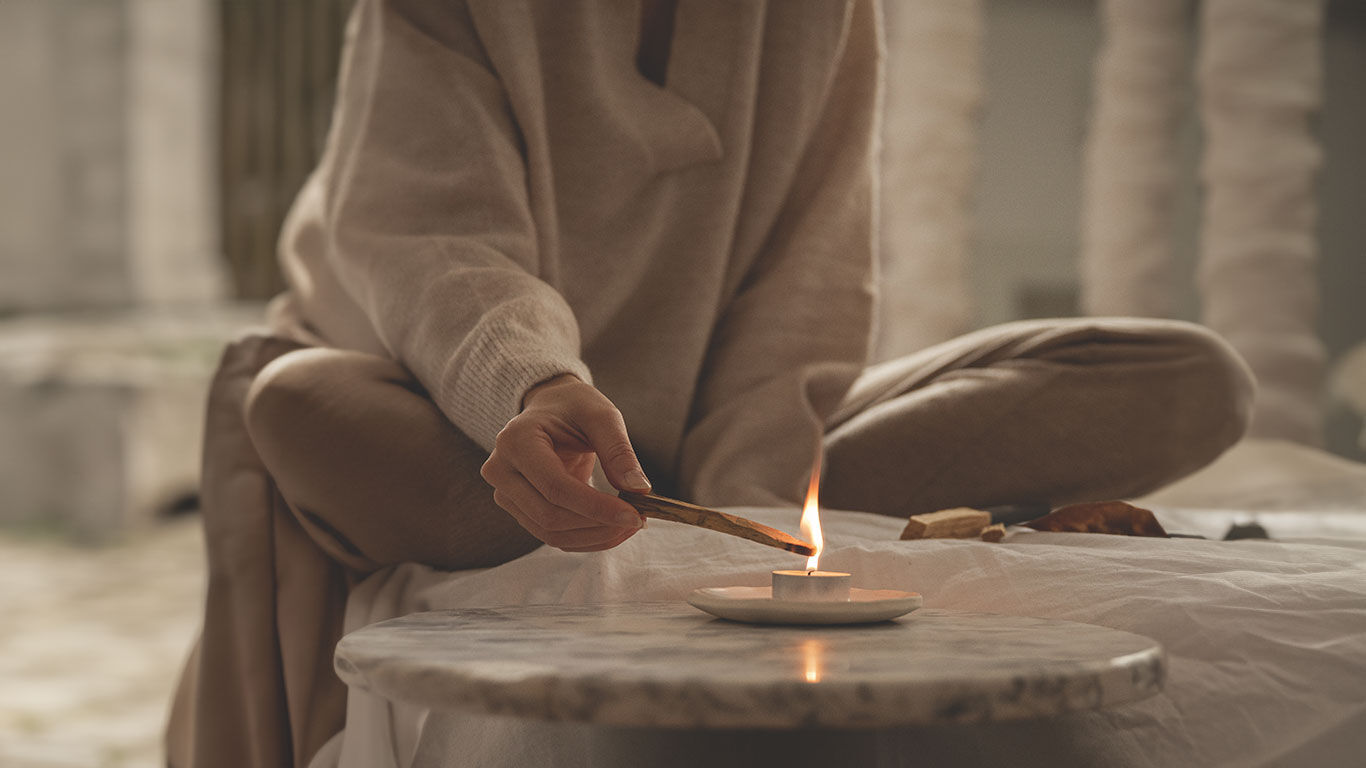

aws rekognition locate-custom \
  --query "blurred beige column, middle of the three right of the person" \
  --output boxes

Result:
[1081,0,1193,317]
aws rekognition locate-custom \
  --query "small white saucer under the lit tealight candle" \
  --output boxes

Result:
[687,586,925,625]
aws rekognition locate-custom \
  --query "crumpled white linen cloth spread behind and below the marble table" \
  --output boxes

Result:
[313,491,1366,768]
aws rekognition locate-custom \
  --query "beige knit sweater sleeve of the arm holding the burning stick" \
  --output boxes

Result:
[301,0,590,450]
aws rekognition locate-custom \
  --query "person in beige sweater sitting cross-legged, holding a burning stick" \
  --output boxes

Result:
[169,0,1251,768]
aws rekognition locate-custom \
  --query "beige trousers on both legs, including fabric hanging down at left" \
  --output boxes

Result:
[168,318,1253,768]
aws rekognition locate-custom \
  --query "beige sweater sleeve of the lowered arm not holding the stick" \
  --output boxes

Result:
[679,0,881,504]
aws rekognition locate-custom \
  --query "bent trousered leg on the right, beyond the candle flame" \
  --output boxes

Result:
[821,318,1253,517]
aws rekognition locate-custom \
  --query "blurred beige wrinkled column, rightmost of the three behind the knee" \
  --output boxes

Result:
[1197,0,1325,444]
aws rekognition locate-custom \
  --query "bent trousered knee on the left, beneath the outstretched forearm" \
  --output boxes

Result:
[246,348,540,571]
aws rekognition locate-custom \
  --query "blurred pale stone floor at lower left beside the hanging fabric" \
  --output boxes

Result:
[0,515,205,768]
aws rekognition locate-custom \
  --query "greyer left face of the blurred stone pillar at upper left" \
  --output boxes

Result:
[0,0,131,316]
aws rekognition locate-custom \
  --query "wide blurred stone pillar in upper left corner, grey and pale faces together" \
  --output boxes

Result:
[0,0,224,313]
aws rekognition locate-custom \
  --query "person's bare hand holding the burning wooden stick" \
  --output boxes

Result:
[479,374,650,552]
